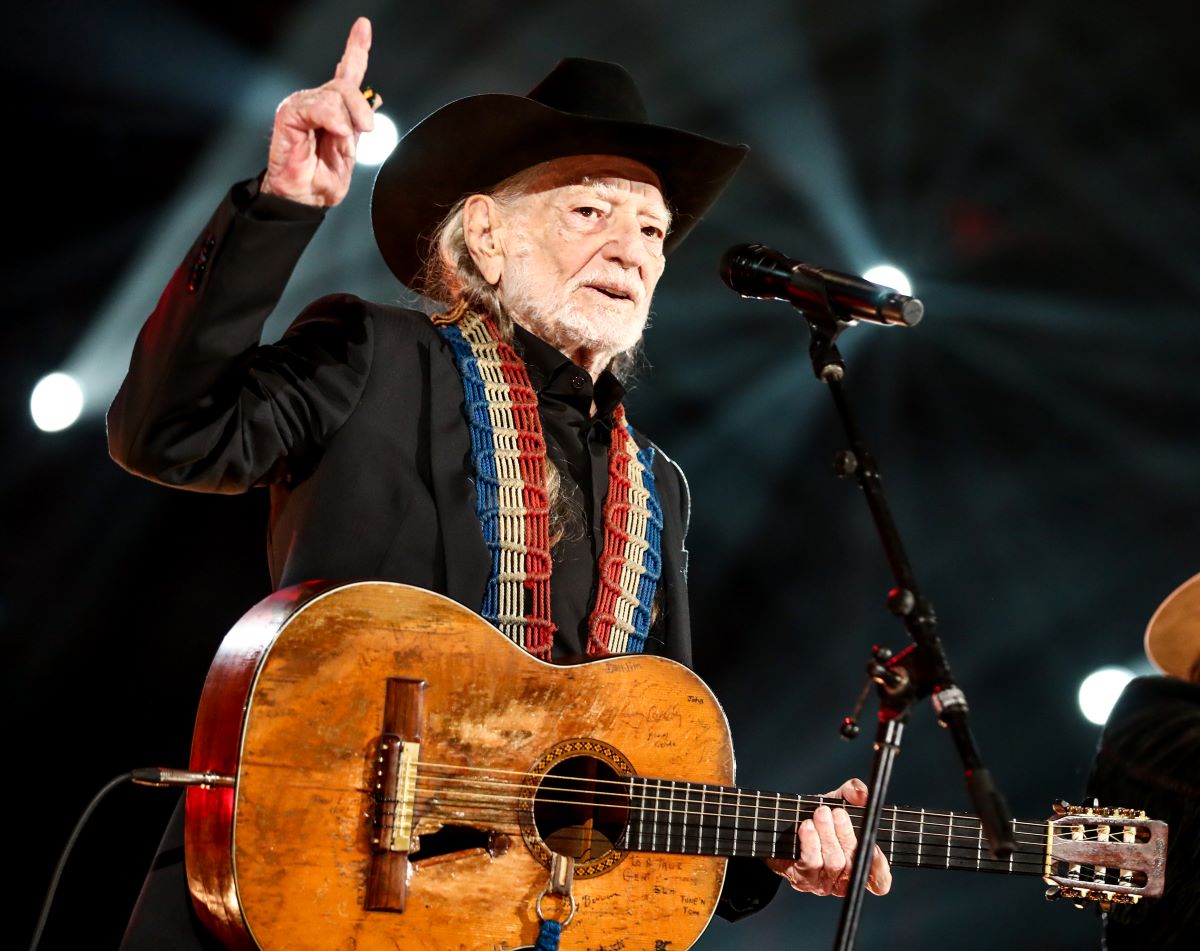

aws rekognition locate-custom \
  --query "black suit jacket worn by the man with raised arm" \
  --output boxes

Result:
[108,185,691,664]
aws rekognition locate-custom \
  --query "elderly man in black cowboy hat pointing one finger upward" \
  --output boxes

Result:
[109,19,890,949]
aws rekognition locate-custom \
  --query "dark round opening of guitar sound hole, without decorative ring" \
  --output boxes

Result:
[533,756,629,862]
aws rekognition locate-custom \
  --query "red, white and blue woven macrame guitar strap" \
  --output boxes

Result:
[433,304,662,659]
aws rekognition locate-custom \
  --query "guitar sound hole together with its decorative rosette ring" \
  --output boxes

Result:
[517,737,634,879]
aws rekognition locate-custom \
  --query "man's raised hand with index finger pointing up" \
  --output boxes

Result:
[263,17,378,208]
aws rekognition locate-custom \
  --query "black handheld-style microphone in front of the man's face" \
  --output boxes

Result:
[721,244,925,327]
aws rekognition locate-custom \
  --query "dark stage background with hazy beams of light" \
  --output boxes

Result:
[7,0,1200,951]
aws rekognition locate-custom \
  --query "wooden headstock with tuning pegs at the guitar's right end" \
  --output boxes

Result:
[1043,802,1166,909]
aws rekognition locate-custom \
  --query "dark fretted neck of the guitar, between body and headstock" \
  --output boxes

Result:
[620,777,1049,875]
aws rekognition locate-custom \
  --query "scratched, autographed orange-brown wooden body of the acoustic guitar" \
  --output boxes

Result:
[186,582,733,951]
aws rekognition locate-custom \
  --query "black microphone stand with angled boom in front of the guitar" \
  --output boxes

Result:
[797,306,1015,951]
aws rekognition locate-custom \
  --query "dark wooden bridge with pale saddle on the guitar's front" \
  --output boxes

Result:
[364,677,425,911]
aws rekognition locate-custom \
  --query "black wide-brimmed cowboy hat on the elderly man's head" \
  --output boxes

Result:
[371,59,749,289]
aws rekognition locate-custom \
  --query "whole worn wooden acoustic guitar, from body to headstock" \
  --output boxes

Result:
[185,582,1166,951]
